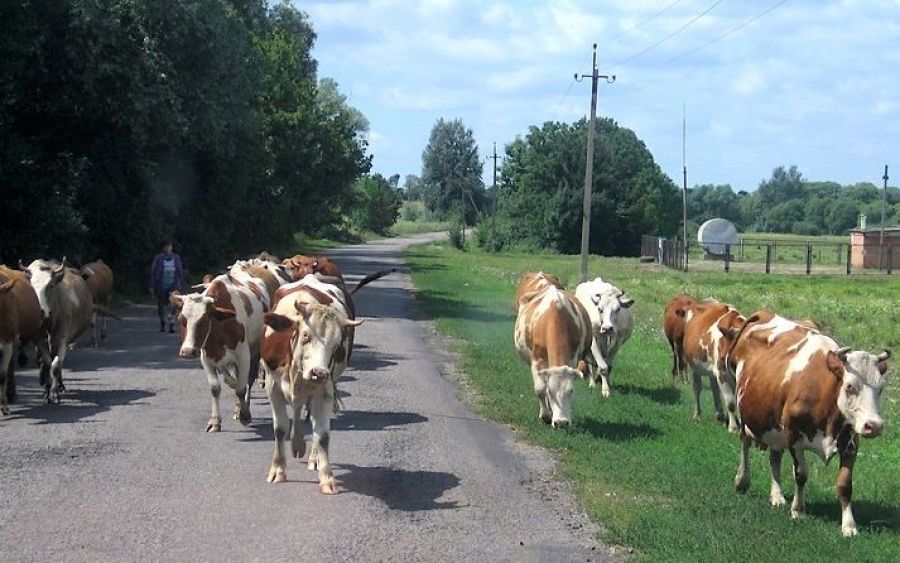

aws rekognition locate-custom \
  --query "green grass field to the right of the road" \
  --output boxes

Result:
[408,245,900,561]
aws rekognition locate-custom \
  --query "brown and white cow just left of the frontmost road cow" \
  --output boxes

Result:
[172,274,266,432]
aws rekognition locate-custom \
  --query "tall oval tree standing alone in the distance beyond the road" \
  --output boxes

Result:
[421,118,484,224]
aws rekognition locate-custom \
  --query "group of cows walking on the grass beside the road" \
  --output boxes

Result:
[515,272,891,536]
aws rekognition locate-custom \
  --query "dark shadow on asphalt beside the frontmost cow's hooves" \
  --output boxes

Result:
[334,464,459,512]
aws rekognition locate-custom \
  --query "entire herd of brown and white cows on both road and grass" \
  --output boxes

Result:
[0,253,890,536]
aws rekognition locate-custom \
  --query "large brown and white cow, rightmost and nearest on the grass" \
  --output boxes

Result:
[728,311,890,536]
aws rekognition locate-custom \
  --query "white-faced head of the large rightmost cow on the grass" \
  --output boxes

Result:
[827,348,891,438]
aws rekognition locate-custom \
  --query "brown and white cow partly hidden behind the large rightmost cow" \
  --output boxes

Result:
[680,296,746,432]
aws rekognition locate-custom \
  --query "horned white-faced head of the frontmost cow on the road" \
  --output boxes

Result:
[265,301,363,382]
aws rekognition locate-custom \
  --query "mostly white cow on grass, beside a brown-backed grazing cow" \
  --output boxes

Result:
[575,277,634,397]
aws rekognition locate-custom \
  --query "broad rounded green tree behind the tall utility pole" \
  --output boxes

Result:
[497,119,680,255]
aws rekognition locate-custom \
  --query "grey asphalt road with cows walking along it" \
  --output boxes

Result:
[0,232,610,561]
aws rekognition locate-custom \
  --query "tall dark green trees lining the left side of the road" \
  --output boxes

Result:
[0,0,399,287]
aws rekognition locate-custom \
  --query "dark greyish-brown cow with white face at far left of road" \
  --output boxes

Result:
[27,258,94,403]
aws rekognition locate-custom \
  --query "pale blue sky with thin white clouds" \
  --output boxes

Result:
[295,0,900,191]
